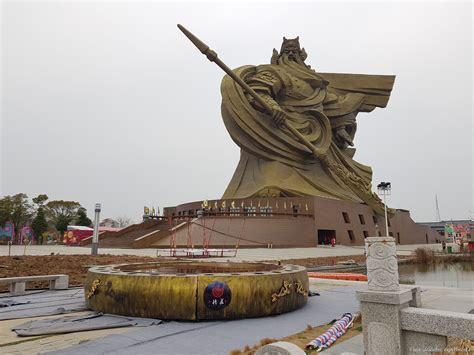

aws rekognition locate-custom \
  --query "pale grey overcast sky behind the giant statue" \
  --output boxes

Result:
[0,2,474,221]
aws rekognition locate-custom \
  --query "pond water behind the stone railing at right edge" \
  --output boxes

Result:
[398,262,474,290]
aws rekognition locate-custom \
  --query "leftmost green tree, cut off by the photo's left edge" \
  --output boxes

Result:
[0,193,33,230]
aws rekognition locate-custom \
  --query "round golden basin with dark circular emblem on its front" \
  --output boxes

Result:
[85,260,309,320]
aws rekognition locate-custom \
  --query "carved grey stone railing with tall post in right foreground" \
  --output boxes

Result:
[357,237,474,355]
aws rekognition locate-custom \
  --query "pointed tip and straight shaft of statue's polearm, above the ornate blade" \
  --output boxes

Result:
[178,24,324,159]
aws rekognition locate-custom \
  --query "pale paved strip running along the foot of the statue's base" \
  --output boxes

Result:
[0,244,441,261]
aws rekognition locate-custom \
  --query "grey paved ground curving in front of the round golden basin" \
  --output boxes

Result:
[0,287,358,354]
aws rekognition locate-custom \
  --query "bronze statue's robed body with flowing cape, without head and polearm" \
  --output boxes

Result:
[221,61,395,214]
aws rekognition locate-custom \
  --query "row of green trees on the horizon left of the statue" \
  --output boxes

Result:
[0,193,92,242]
